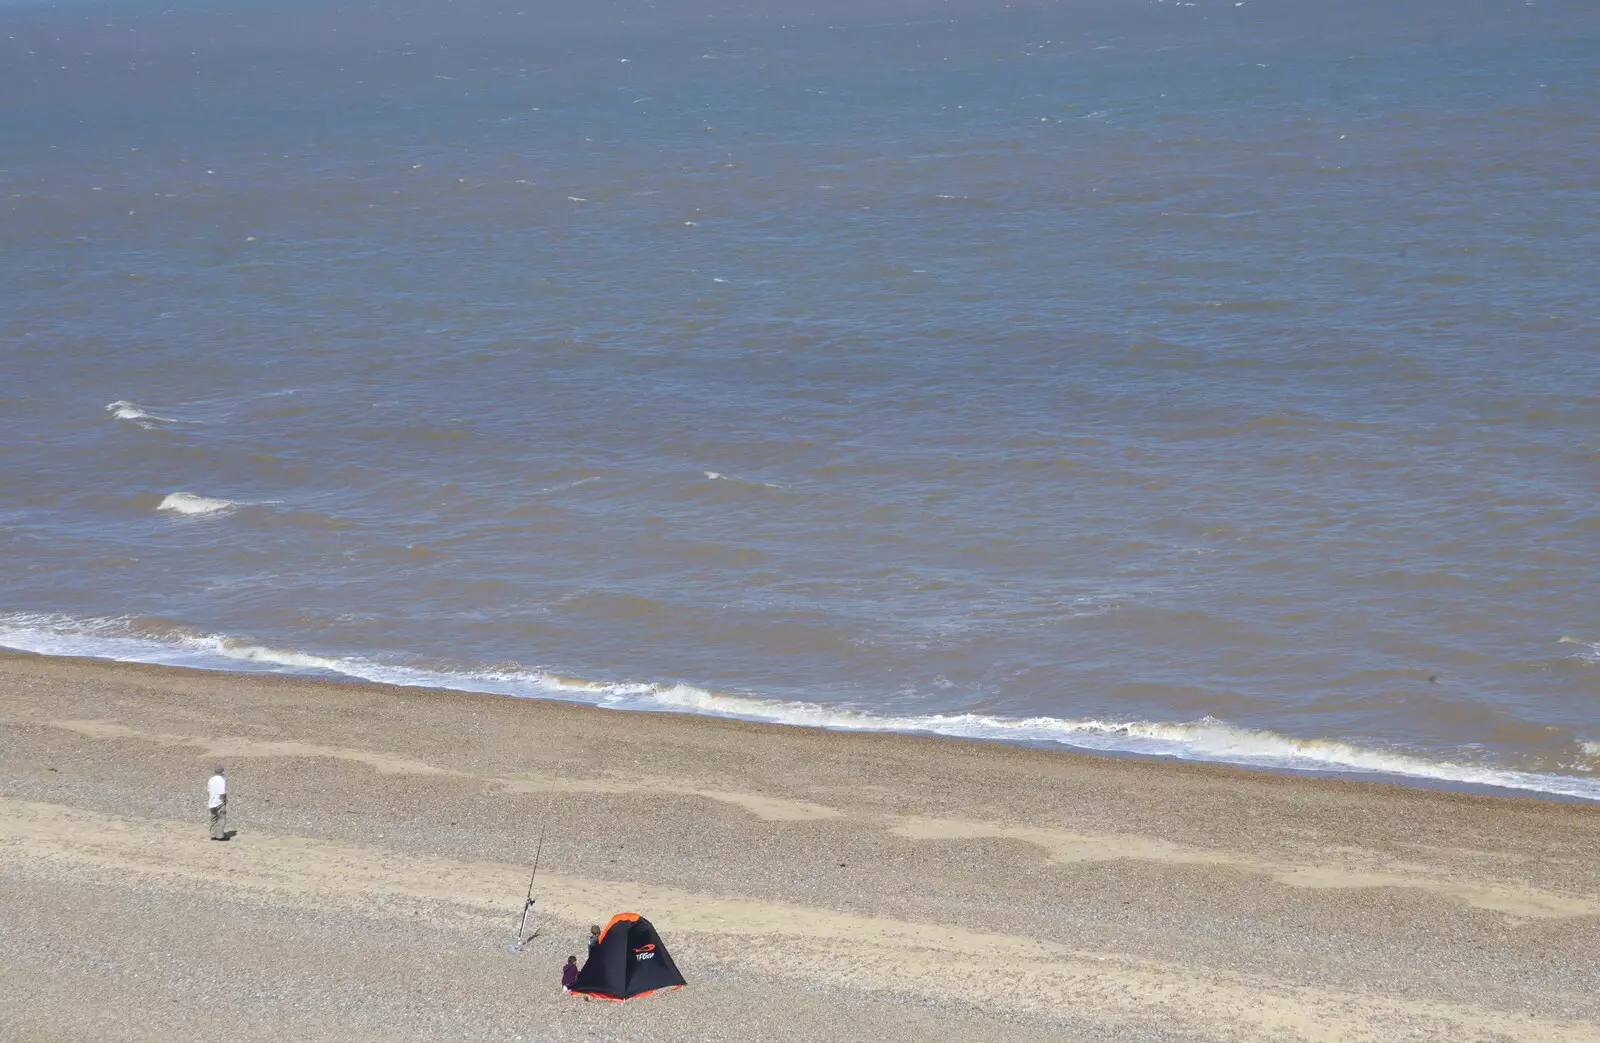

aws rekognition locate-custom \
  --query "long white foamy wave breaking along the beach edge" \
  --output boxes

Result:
[0,613,1600,800]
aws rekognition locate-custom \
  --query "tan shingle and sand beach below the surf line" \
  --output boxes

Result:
[0,654,1600,1043]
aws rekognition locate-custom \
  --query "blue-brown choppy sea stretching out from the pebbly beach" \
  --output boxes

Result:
[0,0,1600,800]
